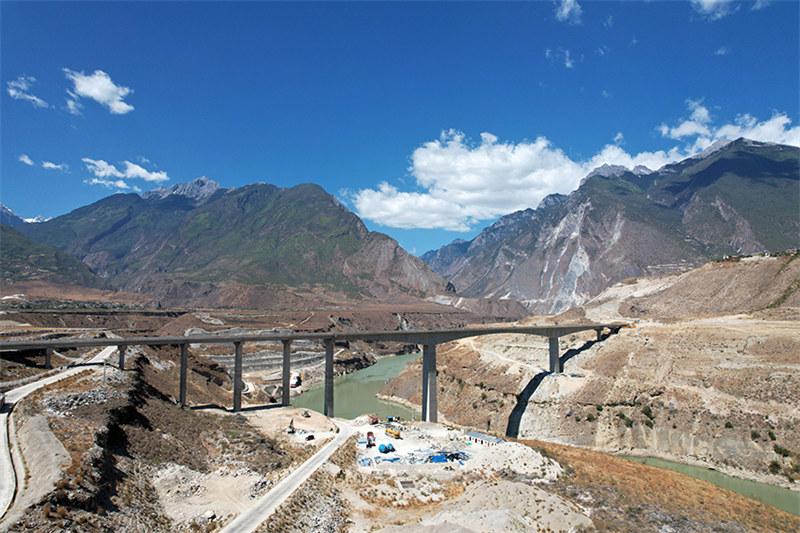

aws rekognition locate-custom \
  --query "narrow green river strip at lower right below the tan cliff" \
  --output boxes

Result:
[623,455,800,516]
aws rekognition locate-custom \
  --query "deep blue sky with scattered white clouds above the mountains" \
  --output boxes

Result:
[0,0,800,254]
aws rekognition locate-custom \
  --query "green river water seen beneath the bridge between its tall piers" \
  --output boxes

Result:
[292,352,421,420]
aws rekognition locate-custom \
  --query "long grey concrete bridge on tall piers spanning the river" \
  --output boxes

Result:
[0,323,625,422]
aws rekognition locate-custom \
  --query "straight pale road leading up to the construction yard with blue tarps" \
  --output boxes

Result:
[222,422,354,533]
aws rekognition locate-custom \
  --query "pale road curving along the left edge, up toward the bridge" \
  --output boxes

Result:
[0,346,117,517]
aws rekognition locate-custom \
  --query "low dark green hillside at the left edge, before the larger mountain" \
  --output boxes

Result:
[0,224,105,288]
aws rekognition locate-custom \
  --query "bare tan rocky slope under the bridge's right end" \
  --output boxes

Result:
[382,253,800,486]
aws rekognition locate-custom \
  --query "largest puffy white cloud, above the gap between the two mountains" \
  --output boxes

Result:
[350,130,585,231]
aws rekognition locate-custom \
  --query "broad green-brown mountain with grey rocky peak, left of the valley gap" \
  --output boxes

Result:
[21,178,447,307]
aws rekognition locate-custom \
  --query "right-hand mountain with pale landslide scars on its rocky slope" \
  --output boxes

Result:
[422,139,800,313]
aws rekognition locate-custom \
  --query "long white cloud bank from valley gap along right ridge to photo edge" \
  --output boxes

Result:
[354,100,800,231]
